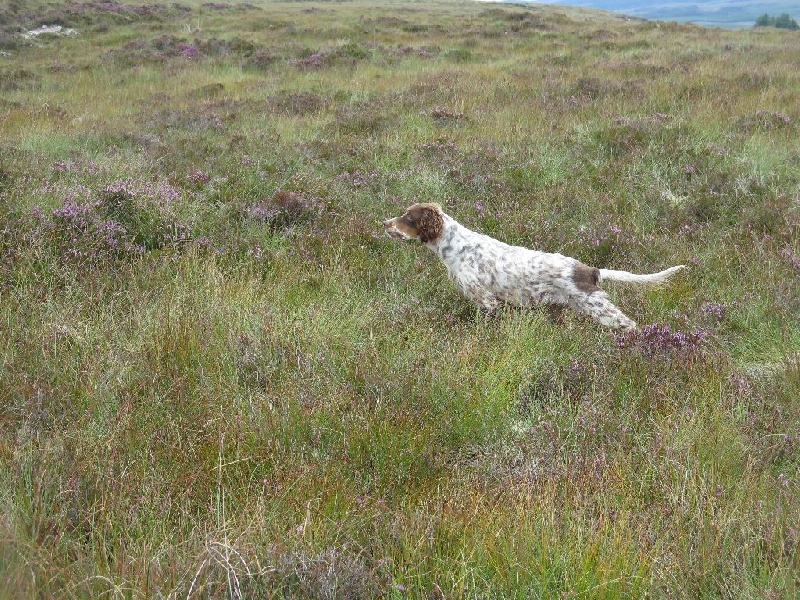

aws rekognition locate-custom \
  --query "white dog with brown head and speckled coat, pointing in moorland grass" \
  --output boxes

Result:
[383,203,684,330]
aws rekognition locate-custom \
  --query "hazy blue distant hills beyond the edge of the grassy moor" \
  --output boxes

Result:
[506,0,800,28]
